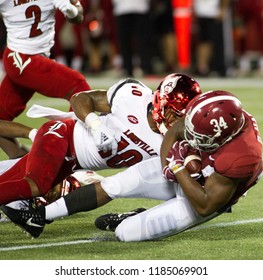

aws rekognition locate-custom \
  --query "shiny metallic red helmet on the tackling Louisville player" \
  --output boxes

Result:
[152,73,201,134]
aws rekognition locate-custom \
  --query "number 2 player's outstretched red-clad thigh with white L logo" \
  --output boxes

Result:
[4,49,90,103]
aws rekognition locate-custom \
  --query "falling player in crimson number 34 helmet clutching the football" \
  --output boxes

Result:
[6,91,262,241]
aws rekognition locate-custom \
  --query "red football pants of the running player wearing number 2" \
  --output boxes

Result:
[0,48,90,120]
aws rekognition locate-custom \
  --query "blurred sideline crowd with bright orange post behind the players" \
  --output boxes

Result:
[0,0,263,79]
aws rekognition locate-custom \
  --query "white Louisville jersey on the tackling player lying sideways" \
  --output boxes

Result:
[74,79,163,170]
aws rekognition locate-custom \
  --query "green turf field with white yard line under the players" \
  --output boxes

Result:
[0,75,263,260]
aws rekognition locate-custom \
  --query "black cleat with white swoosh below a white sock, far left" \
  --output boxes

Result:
[0,201,46,238]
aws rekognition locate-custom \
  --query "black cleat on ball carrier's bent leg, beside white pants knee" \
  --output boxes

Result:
[95,208,146,231]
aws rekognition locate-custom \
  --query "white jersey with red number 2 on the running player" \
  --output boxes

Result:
[0,0,73,55]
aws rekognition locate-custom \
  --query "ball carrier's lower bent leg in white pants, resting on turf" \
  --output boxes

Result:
[115,197,219,241]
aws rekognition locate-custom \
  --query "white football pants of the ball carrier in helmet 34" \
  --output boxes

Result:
[102,157,219,241]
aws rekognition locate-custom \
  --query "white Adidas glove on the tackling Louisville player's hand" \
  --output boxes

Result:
[85,113,118,155]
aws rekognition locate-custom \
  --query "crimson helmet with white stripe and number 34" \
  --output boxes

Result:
[185,90,245,152]
